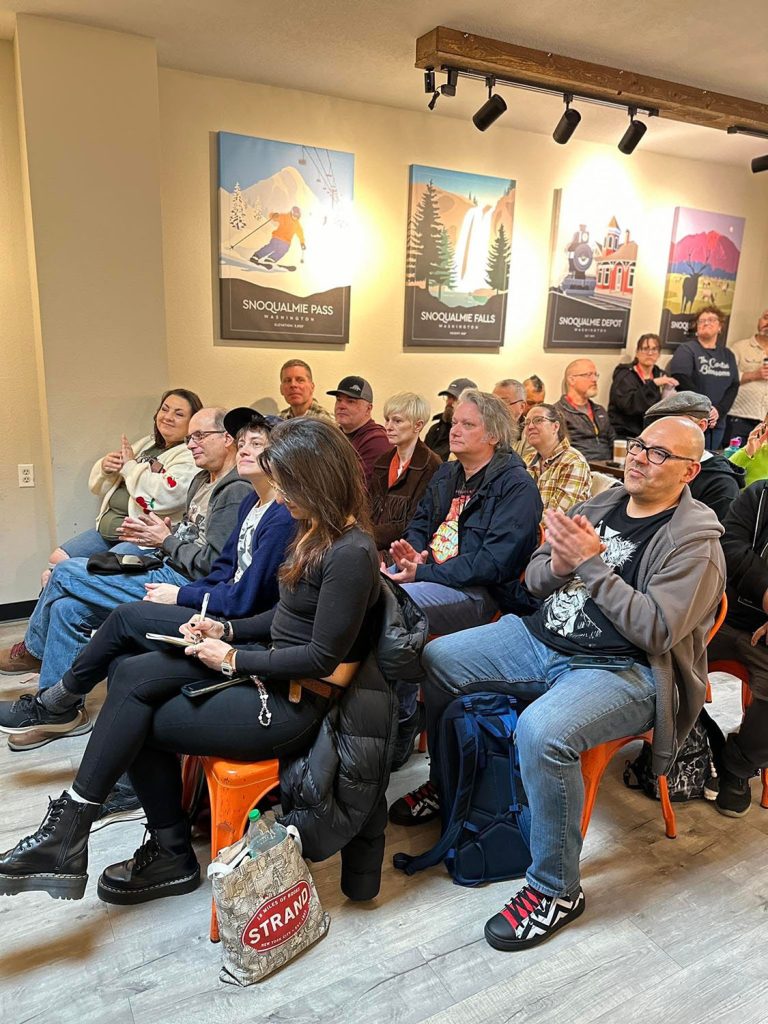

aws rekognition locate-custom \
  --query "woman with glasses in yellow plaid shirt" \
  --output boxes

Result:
[515,402,592,524]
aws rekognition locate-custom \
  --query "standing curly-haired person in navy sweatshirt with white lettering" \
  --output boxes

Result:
[667,306,739,452]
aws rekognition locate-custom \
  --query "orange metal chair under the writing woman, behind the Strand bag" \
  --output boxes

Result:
[182,757,280,942]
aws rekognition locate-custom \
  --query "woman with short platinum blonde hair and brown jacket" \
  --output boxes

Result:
[371,391,442,562]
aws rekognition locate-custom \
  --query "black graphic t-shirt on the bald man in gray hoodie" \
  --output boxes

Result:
[523,495,675,665]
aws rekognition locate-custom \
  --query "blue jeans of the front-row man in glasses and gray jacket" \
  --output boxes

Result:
[24,544,189,689]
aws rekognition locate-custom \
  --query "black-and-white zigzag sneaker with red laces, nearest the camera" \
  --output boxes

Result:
[485,886,585,952]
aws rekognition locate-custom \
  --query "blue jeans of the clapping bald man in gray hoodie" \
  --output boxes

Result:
[423,615,656,896]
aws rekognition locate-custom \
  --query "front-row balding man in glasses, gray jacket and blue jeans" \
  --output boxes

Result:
[0,409,252,750]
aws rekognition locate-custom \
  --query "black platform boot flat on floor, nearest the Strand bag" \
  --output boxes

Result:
[96,818,201,904]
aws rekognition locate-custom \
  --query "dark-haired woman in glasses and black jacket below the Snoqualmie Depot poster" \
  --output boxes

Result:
[608,334,677,437]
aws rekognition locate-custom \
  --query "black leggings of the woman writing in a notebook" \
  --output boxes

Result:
[75,643,328,828]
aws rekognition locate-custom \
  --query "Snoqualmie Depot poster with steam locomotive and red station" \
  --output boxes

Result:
[544,188,640,351]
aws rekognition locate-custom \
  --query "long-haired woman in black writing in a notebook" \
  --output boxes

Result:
[0,419,386,903]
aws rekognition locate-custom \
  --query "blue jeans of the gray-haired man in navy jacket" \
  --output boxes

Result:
[389,566,499,722]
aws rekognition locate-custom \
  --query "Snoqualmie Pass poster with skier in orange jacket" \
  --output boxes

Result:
[218,132,354,344]
